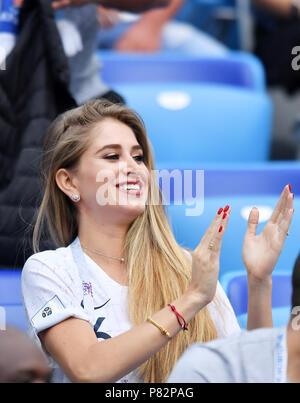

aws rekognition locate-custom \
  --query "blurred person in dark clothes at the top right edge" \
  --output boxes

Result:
[253,0,300,160]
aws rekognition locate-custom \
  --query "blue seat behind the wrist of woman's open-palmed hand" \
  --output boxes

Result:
[220,267,293,329]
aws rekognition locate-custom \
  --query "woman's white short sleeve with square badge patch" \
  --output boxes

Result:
[22,251,89,335]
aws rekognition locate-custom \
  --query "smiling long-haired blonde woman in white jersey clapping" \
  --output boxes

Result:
[22,100,293,382]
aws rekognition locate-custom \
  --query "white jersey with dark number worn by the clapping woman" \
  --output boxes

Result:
[22,237,240,382]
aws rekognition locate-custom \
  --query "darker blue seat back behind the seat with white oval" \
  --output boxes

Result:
[98,50,266,92]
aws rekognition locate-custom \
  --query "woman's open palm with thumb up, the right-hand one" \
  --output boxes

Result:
[242,185,294,280]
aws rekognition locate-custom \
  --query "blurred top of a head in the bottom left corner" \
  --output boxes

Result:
[0,327,51,383]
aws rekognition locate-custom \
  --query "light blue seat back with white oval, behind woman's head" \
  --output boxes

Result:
[115,83,273,163]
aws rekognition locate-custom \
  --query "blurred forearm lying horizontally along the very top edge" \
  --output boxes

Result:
[52,0,170,13]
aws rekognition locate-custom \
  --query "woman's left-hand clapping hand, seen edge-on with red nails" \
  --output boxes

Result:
[189,206,230,304]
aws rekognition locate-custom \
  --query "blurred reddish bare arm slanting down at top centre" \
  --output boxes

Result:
[115,0,185,52]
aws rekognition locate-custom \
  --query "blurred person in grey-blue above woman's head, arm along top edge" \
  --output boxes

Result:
[52,0,168,104]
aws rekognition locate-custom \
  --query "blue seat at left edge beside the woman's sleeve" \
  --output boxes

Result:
[0,269,27,331]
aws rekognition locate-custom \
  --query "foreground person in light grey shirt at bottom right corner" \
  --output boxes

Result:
[168,255,300,383]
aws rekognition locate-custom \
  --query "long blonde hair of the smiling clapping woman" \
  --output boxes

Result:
[33,100,217,382]
